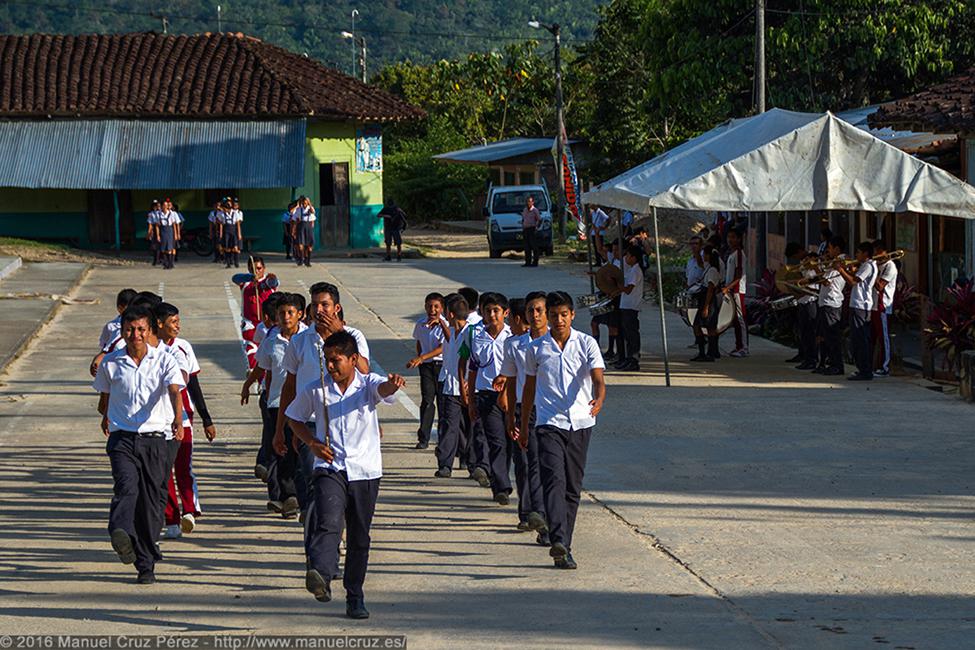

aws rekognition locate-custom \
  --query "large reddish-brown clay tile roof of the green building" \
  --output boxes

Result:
[0,32,423,122]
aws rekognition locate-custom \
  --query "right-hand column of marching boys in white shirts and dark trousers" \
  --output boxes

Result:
[407,287,606,569]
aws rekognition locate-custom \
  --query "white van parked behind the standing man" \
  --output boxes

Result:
[484,185,552,258]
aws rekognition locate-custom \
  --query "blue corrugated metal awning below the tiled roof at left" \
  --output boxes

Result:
[0,119,306,190]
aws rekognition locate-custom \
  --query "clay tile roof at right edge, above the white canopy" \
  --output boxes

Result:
[868,68,975,133]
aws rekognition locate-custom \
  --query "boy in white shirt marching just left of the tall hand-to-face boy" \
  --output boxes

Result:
[240,292,308,519]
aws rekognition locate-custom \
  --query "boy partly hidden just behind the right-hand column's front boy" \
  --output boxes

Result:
[494,291,550,546]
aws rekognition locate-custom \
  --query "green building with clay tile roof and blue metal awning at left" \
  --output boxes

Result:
[0,33,422,250]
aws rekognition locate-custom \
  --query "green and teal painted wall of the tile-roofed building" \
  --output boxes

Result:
[0,122,383,251]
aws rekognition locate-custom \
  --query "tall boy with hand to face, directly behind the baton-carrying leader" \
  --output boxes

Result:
[274,282,369,520]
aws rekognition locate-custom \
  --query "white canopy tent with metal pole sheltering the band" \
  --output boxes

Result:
[582,109,975,385]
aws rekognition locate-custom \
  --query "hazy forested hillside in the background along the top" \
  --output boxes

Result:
[0,0,605,72]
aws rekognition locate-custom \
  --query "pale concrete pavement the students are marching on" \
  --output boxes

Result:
[0,254,975,648]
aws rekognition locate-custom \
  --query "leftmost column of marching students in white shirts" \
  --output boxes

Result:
[89,289,217,584]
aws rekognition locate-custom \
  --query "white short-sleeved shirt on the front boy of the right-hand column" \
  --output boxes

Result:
[525,329,606,431]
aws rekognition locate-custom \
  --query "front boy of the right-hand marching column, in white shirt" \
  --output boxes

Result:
[518,291,606,569]
